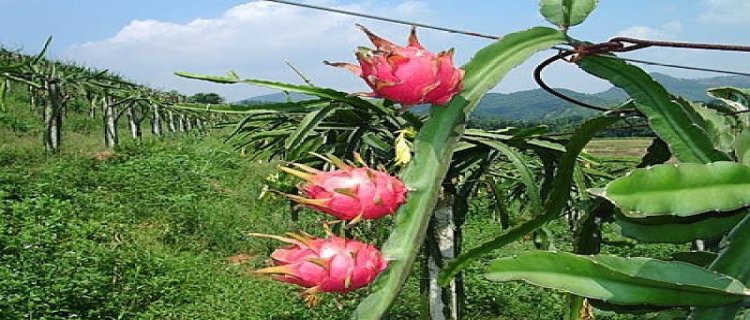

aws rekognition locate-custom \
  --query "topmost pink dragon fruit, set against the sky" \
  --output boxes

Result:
[326,25,464,107]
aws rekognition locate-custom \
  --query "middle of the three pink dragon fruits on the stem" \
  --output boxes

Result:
[281,157,407,224]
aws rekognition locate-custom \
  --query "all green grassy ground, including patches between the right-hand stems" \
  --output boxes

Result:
[0,96,688,320]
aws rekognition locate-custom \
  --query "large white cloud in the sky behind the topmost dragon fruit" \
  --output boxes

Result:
[65,1,445,100]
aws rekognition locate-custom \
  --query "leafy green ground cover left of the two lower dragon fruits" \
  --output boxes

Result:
[0,129,394,319]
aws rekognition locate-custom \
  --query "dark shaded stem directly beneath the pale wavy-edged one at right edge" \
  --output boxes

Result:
[615,210,745,243]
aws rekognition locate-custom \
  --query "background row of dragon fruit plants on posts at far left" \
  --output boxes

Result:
[0,39,203,153]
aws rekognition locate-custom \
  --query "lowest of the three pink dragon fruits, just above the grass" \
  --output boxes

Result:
[251,233,387,305]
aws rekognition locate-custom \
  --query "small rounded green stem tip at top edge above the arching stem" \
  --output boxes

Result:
[539,0,599,30]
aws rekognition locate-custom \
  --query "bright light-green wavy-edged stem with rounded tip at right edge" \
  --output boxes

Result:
[603,161,750,218]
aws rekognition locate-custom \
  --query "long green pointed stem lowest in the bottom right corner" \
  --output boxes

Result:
[486,252,750,306]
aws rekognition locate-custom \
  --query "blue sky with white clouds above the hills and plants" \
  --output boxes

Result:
[0,0,750,100]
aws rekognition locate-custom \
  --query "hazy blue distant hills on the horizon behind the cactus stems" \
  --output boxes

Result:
[239,73,750,121]
